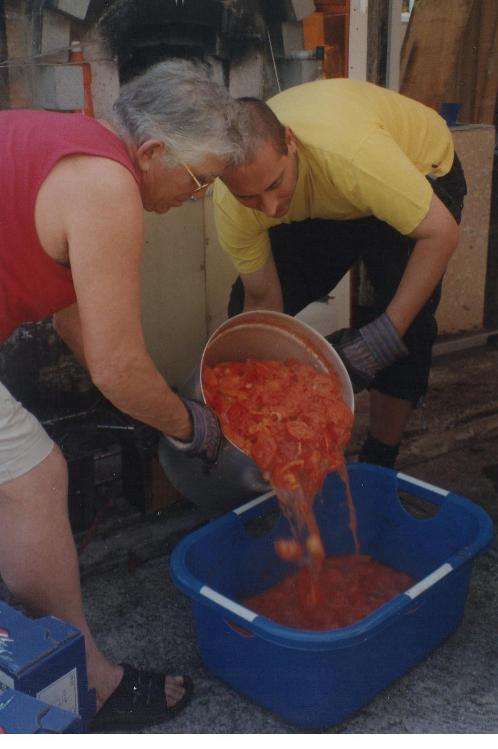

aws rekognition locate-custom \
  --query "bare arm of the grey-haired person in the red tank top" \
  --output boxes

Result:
[59,159,191,440]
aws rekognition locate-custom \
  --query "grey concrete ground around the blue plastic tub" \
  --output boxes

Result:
[77,349,498,734]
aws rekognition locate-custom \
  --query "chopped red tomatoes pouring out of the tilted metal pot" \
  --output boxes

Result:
[203,359,353,566]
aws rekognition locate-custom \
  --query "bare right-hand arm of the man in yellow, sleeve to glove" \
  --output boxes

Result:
[386,195,459,336]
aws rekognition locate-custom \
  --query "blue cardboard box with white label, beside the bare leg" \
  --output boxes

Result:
[0,601,96,723]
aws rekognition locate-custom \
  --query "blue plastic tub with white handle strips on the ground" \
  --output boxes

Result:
[171,463,492,729]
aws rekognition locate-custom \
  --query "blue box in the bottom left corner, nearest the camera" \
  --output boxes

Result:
[0,689,83,733]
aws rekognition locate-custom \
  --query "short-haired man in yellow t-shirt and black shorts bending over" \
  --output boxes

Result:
[214,79,466,466]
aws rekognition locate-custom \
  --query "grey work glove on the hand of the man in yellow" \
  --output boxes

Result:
[326,313,408,393]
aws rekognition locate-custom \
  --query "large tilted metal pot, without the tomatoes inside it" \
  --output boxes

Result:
[159,310,354,516]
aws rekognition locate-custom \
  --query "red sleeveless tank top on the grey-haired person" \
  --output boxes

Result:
[0,110,139,343]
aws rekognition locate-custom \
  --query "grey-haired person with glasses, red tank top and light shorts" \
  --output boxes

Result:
[0,61,238,729]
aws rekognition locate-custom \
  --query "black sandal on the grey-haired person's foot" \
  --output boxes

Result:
[90,663,194,733]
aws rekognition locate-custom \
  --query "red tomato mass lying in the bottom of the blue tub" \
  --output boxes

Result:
[244,554,414,631]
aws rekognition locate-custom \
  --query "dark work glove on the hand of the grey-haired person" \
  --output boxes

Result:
[165,398,223,464]
